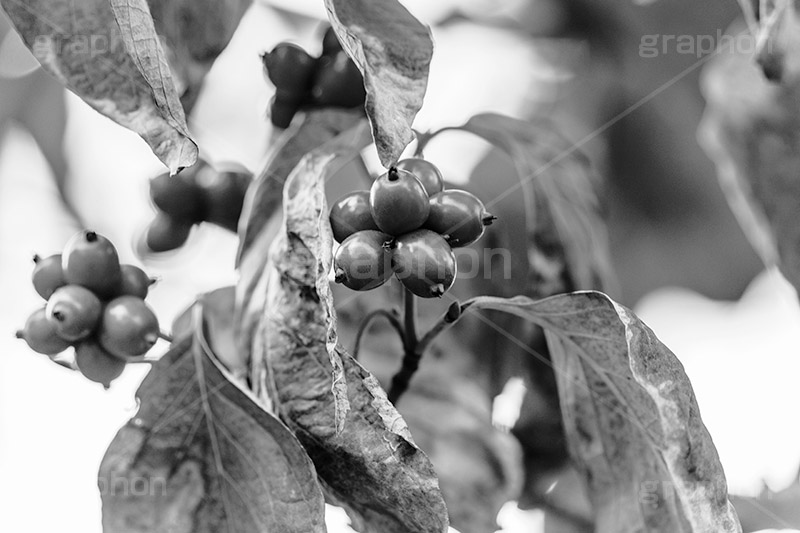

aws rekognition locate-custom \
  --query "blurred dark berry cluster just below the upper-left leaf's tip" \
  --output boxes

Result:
[143,161,253,252]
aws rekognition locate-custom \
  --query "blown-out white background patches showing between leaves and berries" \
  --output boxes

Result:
[0,0,800,533]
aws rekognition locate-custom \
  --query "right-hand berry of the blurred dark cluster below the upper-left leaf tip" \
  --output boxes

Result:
[196,167,253,232]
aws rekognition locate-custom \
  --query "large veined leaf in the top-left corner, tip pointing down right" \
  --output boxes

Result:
[0,0,197,173]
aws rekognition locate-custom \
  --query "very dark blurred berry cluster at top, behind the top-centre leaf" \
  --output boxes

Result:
[261,28,366,128]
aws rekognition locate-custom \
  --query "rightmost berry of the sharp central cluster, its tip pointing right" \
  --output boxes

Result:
[424,189,496,247]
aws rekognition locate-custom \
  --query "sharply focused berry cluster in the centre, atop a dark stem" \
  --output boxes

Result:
[330,158,495,298]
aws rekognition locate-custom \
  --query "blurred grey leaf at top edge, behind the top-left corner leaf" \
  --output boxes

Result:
[147,0,252,113]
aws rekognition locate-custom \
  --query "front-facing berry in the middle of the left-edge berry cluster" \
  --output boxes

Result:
[45,285,103,341]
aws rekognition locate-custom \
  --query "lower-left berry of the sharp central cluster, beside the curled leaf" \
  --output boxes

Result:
[333,230,392,291]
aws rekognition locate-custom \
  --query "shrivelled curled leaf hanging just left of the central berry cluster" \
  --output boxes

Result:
[253,149,447,533]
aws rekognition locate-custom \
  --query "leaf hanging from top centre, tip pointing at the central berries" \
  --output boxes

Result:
[325,0,433,168]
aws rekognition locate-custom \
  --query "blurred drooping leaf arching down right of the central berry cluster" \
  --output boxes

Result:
[457,113,616,298]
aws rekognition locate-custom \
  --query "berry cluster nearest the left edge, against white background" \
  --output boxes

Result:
[17,231,159,387]
